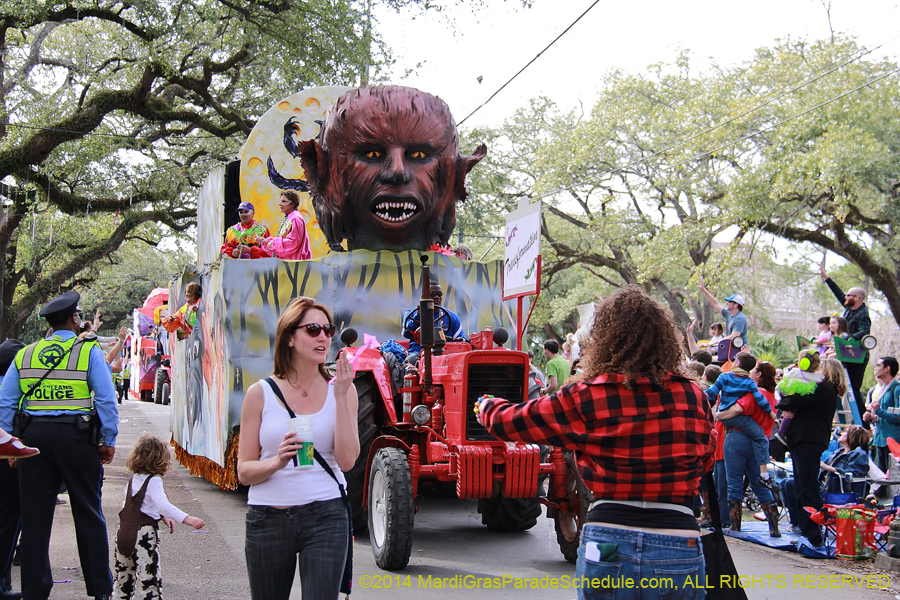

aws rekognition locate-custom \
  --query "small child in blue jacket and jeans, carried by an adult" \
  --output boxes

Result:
[706,352,774,489]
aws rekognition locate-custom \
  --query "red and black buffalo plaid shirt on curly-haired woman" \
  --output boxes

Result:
[480,374,714,504]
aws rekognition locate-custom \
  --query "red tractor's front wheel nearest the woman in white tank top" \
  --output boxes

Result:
[369,448,415,570]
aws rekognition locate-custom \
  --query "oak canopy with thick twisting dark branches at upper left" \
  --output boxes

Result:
[0,0,528,337]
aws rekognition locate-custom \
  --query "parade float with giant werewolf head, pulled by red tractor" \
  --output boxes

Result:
[162,87,586,568]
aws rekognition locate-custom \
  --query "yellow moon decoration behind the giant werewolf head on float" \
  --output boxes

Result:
[239,85,352,258]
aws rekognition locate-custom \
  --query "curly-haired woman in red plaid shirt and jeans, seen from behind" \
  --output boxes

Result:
[476,286,713,600]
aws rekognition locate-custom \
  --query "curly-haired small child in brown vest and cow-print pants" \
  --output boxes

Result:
[113,433,203,600]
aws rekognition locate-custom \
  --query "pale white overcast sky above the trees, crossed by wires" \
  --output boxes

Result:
[376,0,900,127]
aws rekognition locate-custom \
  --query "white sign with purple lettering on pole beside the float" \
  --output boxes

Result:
[503,198,541,300]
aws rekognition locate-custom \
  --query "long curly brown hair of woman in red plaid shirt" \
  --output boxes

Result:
[582,285,683,379]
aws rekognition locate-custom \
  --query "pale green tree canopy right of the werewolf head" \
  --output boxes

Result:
[458,39,900,338]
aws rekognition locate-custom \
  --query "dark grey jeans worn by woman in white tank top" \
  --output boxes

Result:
[244,498,350,600]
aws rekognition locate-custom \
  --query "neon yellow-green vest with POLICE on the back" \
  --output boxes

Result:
[16,336,97,411]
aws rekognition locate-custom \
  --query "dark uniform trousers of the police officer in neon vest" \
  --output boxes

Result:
[19,420,112,600]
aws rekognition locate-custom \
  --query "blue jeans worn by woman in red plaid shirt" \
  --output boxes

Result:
[575,523,706,600]
